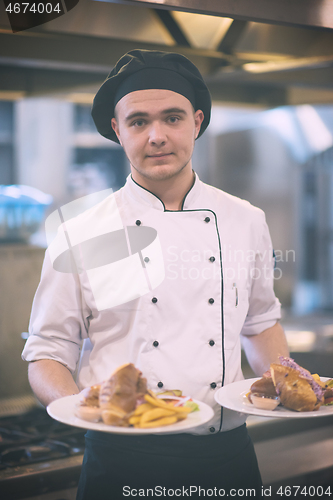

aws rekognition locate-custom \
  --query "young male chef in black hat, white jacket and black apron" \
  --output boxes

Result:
[22,50,288,500]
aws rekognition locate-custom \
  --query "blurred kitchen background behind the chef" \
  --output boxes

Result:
[0,0,333,499]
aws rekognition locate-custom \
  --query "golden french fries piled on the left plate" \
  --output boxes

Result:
[128,392,191,429]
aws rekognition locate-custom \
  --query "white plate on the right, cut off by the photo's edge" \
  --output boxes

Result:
[215,377,333,418]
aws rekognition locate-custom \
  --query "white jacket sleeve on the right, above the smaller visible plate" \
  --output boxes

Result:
[241,220,281,335]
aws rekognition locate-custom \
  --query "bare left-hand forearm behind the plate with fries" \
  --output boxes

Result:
[28,359,79,406]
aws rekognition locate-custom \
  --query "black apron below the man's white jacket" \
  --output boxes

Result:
[77,424,262,500]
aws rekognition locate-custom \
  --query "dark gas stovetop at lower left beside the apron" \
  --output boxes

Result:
[0,408,85,499]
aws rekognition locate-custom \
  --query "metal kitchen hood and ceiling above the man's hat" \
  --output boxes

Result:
[0,0,333,106]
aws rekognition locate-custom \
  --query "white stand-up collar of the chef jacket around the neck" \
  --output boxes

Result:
[124,172,202,211]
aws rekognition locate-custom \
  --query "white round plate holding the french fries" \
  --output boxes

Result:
[47,394,214,435]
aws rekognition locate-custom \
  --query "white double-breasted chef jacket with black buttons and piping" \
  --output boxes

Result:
[22,175,280,434]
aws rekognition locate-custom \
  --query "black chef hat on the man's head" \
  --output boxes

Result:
[91,49,211,142]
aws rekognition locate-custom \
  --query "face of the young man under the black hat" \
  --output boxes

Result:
[111,89,204,182]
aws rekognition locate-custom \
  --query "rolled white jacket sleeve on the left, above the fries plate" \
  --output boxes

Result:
[22,251,90,373]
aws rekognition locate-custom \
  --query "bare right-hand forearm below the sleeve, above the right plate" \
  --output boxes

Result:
[242,322,289,377]
